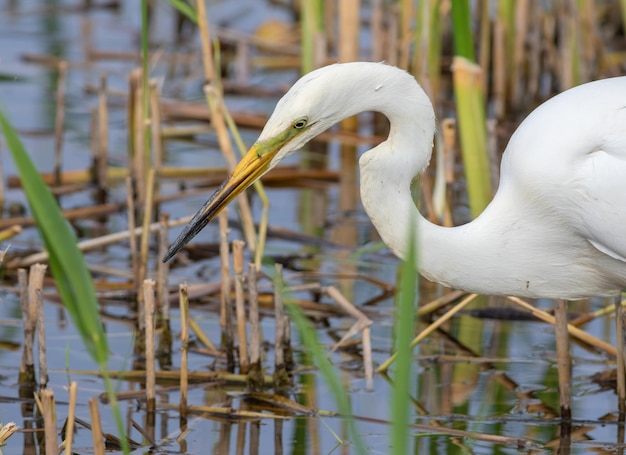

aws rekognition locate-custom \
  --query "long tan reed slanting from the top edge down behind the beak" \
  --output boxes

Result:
[196,0,256,251]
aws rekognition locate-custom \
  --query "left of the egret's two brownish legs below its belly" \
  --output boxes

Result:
[554,299,572,420]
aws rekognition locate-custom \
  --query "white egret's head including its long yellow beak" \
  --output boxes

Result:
[163,62,400,261]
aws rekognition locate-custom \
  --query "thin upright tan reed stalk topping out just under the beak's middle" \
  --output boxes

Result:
[218,209,235,371]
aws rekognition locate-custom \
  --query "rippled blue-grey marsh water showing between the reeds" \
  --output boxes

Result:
[0,0,623,455]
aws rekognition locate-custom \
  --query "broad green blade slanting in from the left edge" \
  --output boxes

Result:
[0,111,109,366]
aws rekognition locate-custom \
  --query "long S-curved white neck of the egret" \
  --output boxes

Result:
[359,71,490,289]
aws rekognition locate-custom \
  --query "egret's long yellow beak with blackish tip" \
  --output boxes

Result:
[163,142,282,262]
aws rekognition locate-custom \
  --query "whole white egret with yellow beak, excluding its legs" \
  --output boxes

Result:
[166,62,626,299]
